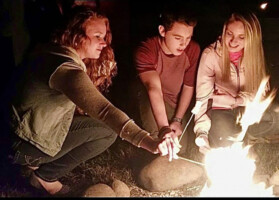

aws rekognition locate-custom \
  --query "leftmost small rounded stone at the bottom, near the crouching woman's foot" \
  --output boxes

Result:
[83,183,116,197]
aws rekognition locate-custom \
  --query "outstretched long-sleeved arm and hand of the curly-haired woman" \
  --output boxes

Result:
[50,67,179,157]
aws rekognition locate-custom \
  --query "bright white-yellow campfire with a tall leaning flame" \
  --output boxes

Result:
[200,78,275,197]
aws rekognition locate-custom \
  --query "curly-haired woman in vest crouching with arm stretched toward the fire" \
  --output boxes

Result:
[10,6,179,195]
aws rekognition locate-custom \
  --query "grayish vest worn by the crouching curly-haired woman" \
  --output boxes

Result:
[11,46,86,156]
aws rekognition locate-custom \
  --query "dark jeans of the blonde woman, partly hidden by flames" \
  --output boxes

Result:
[209,104,279,147]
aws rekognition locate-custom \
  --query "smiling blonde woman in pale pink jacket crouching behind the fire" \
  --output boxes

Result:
[194,13,278,153]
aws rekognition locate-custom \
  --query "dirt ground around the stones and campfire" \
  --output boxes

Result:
[0,126,279,197]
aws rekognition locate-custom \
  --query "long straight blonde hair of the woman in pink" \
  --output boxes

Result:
[221,13,267,93]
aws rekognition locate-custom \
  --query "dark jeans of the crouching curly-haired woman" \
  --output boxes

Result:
[10,116,117,182]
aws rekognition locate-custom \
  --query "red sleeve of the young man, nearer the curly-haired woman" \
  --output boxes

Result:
[135,37,158,74]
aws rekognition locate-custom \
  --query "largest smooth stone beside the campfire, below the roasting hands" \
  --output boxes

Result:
[138,156,204,192]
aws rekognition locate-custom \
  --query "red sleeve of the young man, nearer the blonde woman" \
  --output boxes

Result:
[183,40,201,87]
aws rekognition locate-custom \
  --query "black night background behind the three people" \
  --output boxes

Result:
[0,0,279,188]
